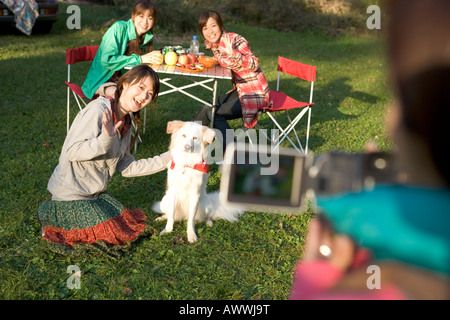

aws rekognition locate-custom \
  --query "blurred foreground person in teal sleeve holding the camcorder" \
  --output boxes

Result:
[290,0,450,299]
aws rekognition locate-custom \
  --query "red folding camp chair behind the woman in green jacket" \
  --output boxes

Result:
[66,46,98,132]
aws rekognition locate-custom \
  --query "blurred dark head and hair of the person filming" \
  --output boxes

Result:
[385,0,450,186]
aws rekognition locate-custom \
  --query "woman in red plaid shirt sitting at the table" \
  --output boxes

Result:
[195,11,271,150]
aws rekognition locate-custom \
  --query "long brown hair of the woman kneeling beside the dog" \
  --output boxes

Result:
[114,64,160,149]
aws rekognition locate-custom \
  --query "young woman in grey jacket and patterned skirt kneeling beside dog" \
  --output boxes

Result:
[38,64,170,255]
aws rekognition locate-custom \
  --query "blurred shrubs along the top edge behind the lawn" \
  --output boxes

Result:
[113,0,379,35]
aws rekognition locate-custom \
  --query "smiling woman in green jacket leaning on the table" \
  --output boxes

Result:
[81,0,161,99]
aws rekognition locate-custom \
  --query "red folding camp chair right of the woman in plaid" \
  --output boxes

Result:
[261,57,317,154]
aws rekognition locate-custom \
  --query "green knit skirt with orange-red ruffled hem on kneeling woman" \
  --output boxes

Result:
[38,192,150,251]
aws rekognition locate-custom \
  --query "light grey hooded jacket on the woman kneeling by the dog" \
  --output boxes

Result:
[48,97,170,201]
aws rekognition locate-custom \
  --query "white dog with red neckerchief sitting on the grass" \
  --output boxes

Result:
[152,120,243,243]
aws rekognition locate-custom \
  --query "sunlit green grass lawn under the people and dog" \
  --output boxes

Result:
[0,3,392,300]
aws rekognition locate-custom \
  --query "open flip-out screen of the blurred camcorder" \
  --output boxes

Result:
[220,144,306,211]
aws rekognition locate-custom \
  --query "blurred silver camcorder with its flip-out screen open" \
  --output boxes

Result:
[220,143,401,213]
